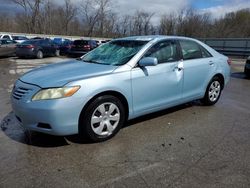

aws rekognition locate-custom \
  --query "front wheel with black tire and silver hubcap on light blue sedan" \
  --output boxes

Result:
[79,95,126,142]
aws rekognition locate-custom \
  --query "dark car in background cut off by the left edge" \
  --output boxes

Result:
[0,39,17,56]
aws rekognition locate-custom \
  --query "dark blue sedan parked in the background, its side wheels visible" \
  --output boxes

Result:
[16,39,60,59]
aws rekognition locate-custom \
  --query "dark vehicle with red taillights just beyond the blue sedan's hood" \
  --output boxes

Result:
[68,40,98,57]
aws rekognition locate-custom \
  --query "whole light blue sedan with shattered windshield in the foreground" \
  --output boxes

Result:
[11,36,230,142]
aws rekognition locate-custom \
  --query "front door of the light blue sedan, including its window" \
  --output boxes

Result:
[131,40,183,115]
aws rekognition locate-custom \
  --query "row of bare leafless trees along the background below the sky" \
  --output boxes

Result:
[0,0,250,38]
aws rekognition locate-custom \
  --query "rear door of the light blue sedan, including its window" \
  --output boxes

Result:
[179,40,215,101]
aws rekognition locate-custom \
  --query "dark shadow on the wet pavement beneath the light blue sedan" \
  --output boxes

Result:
[0,101,201,148]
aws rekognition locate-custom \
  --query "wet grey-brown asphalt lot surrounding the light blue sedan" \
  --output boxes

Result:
[0,58,250,188]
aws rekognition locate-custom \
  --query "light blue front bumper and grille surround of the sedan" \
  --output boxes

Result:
[11,80,82,136]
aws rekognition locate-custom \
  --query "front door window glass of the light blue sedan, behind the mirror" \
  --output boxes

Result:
[144,41,178,63]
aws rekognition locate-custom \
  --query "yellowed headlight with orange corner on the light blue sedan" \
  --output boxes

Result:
[32,86,80,101]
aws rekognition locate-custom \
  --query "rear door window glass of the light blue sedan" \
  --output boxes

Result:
[180,40,202,60]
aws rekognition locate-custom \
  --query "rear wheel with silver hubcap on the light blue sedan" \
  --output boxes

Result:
[201,76,222,106]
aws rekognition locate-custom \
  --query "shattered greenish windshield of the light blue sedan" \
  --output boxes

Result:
[82,40,148,65]
